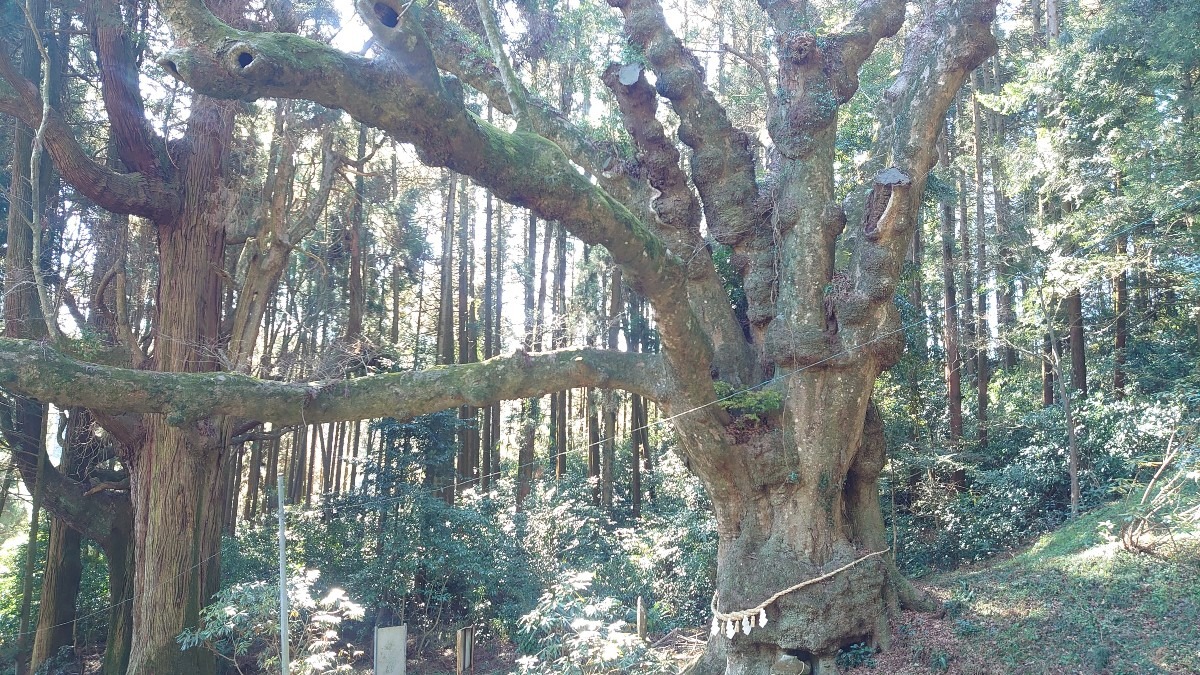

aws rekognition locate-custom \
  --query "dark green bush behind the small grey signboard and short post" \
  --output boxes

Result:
[226,473,539,652]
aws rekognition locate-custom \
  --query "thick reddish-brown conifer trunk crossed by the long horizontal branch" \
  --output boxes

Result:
[130,96,235,675]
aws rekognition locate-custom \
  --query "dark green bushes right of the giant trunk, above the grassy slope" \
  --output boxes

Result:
[884,395,1186,573]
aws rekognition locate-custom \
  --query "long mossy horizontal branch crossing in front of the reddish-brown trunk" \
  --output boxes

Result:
[0,339,668,425]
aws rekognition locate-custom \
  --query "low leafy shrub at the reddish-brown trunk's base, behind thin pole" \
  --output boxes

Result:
[176,569,362,675]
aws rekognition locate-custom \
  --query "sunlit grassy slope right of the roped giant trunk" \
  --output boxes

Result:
[853,504,1200,675]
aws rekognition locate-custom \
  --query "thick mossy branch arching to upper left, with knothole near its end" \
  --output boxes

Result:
[160,0,713,395]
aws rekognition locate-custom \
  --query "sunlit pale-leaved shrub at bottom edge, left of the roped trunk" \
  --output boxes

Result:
[517,572,676,675]
